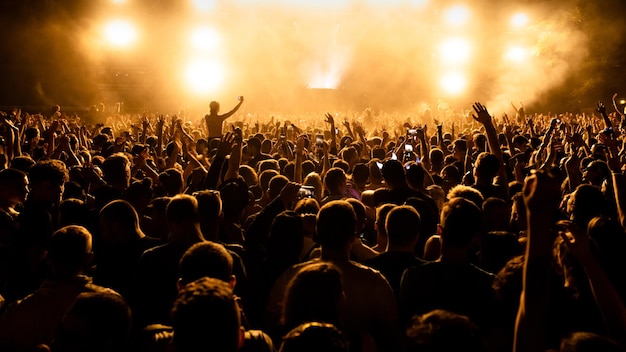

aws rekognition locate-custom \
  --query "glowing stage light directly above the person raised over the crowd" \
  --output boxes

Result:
[184,59,225,94]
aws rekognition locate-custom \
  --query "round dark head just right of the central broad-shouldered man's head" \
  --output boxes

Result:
[385,205,421,247]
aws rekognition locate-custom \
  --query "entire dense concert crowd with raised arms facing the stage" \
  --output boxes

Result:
[0,97,626,352]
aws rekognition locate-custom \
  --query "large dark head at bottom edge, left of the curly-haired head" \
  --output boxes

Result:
[51,291,131,352]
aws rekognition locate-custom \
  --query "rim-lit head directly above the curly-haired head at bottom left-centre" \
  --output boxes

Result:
[179,241,233,285]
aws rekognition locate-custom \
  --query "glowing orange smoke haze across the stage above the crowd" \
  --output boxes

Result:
[6,0,608,116]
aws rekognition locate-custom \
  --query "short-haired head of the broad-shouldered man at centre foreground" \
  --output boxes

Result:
[317,200,356,250]
